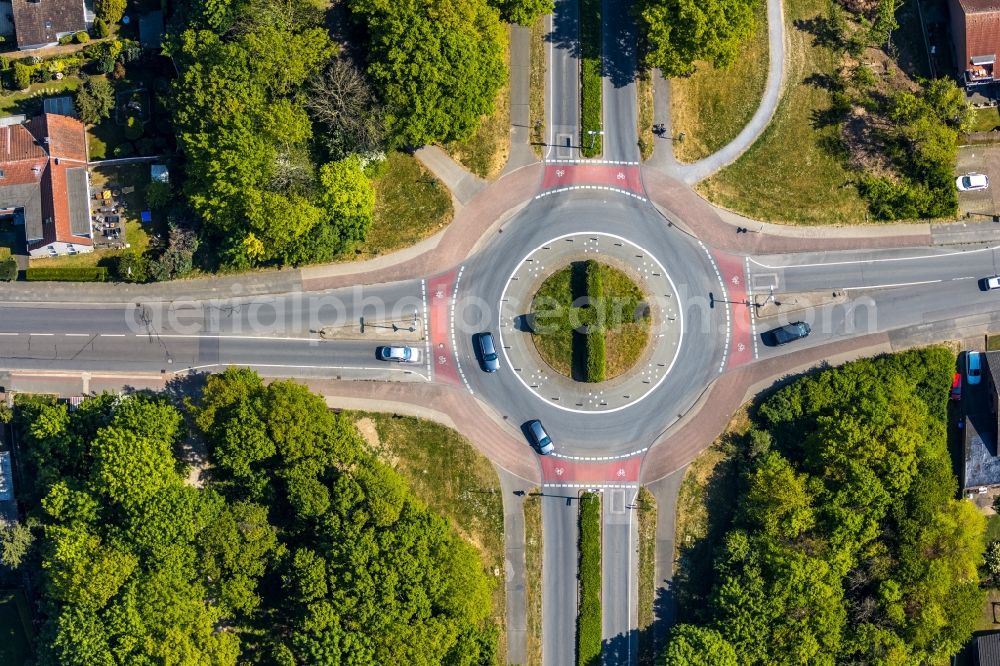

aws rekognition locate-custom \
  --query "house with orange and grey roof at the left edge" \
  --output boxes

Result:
[0,114,94,257]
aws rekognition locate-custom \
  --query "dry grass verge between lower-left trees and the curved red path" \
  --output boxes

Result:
[351,412,507,664]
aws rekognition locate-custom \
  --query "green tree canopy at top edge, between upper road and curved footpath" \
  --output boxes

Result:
[634,0,759,77]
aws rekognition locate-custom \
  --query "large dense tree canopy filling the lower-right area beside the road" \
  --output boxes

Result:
[668,348,984,664]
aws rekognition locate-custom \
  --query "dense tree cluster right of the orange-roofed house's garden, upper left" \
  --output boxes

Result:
[171,0,374,268]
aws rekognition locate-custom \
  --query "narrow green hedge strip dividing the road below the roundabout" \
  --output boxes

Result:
[576,493,601,666]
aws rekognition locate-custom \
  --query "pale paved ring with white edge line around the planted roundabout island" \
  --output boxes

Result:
[498,232,683,413]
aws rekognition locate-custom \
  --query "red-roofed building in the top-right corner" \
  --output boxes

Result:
[948,0,1000,86]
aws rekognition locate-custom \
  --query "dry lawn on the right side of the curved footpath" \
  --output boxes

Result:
[698,0,866,224]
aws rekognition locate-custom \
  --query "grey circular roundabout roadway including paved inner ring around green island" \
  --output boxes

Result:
[452,187,730,458]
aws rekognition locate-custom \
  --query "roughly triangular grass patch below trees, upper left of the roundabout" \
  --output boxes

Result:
[355,152,454,259]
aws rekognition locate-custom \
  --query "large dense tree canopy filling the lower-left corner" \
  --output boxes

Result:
[13,370,497,666]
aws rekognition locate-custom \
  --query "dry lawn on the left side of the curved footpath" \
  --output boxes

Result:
[670,0,768,162]
